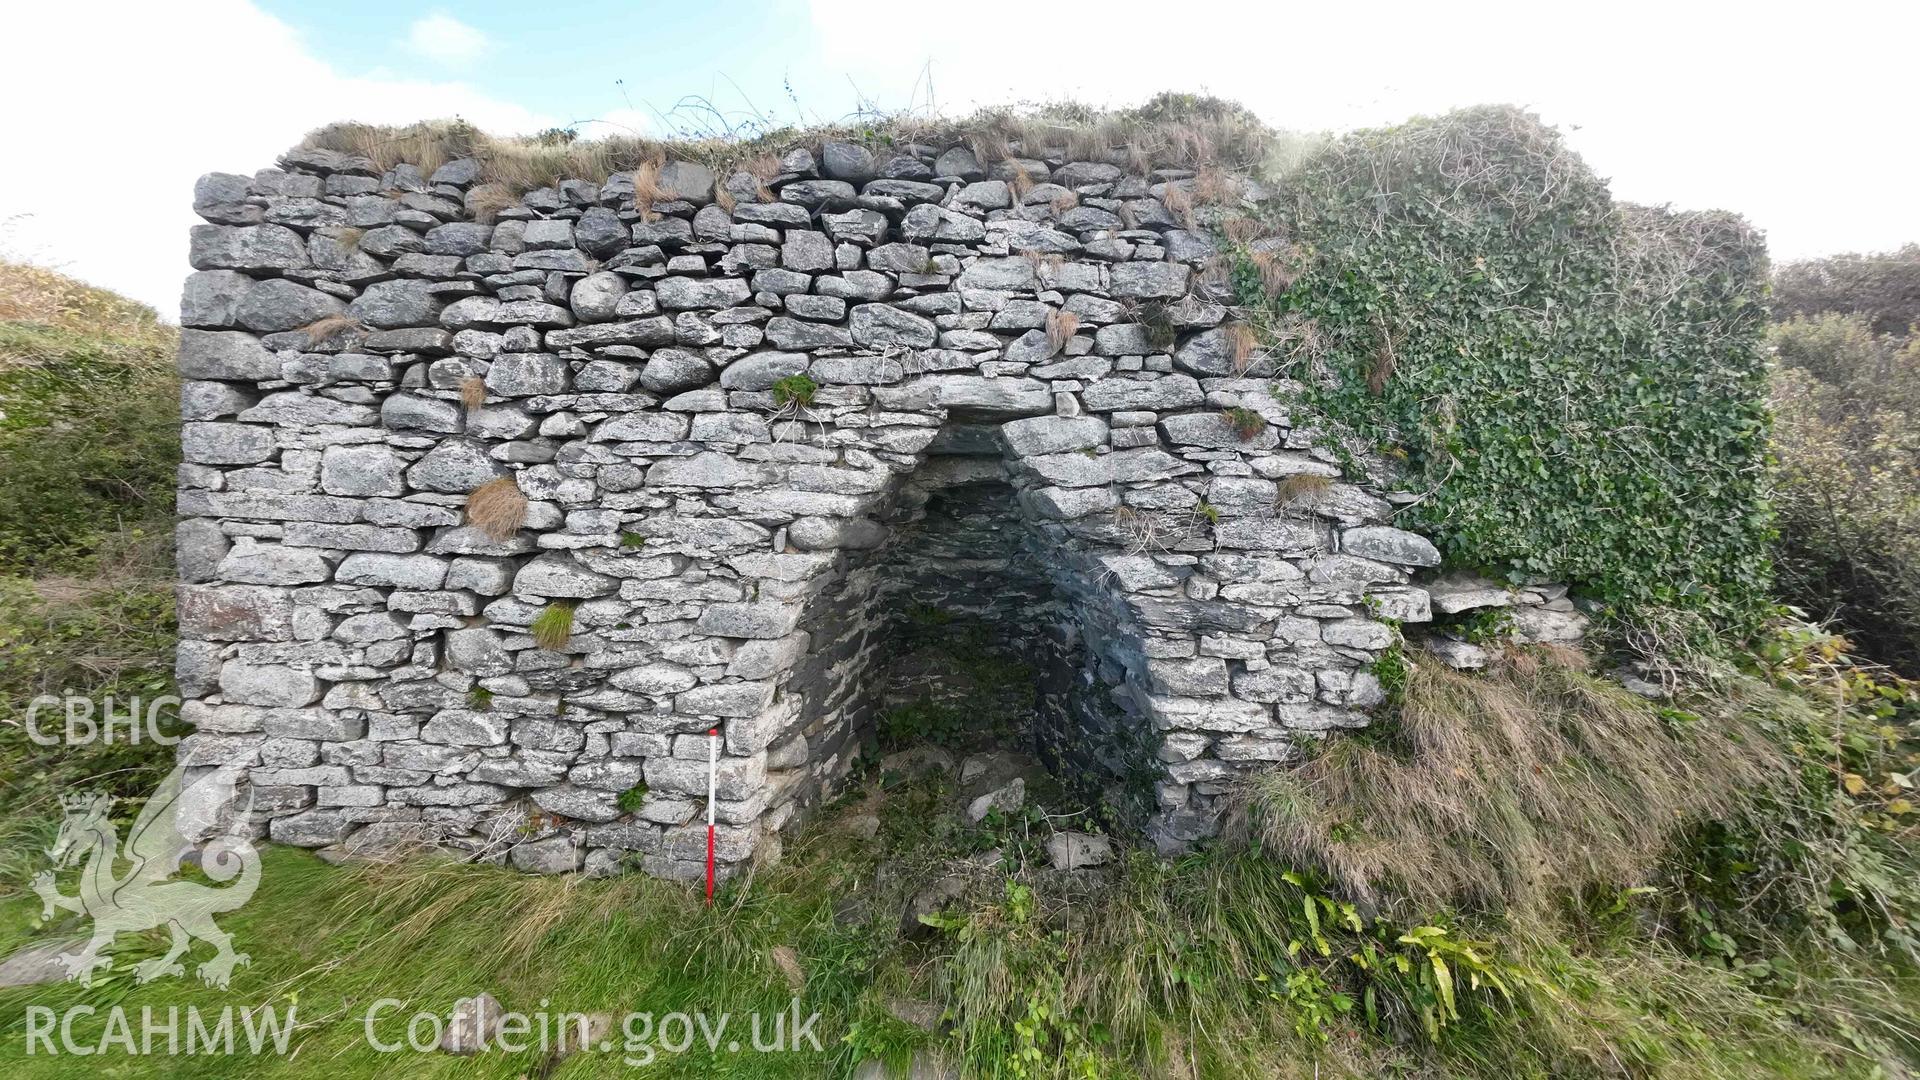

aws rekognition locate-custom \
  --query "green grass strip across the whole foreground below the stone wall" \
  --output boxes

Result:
[0,749,1904,1078]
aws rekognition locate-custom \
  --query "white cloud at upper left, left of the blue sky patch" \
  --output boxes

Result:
[0,0,557,319]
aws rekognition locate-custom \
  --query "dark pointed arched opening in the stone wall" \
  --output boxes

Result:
[789,419,1158,828]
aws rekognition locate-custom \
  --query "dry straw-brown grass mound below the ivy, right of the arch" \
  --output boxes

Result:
[1261,651,1786,917]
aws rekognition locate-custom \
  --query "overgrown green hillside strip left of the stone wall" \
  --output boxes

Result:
[0,263,179,874]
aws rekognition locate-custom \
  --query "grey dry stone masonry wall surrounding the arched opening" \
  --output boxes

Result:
[179,134,1580,876]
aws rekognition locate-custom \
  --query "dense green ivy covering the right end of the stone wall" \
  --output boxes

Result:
[1229,108,1772,628]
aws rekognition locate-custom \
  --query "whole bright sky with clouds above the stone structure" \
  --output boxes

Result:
[0,0,1920,319]
